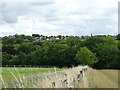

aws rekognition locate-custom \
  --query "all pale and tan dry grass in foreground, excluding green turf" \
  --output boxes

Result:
[0,66,118,88]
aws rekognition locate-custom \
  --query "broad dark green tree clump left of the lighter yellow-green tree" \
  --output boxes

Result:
[30,42,75,67]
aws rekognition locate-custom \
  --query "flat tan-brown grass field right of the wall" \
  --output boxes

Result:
[87,69,118,88]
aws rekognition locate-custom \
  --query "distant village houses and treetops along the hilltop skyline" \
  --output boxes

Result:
[0,34,117,42]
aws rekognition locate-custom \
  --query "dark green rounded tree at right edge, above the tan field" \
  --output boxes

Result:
[94,44,120,69]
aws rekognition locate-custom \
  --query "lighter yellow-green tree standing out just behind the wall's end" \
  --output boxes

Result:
[75,47,97,66]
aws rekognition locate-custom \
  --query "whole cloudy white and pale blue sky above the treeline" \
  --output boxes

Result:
[0,0,119,36]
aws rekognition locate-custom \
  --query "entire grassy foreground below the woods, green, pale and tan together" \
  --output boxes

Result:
[2,66,118,88]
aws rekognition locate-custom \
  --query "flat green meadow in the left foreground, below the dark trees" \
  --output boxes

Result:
[0,67,62,88]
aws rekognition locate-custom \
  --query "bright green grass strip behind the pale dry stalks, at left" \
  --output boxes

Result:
[2,67,62,82]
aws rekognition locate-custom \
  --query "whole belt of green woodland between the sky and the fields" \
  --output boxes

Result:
[0,34,120,69]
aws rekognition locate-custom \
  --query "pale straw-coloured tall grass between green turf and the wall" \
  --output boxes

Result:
[1,66,86,88]
